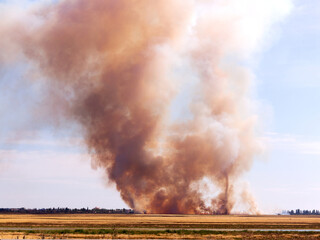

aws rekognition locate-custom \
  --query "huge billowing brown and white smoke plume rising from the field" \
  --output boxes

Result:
[0,0,289,213]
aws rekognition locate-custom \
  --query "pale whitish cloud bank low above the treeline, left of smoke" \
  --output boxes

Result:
[0,138,127,208]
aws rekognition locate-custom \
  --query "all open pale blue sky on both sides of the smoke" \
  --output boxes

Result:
[0,0,320,213]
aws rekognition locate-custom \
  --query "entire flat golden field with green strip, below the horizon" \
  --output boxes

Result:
[0,214,320,239]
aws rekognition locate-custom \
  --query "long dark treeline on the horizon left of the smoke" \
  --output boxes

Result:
[0,208,135,214]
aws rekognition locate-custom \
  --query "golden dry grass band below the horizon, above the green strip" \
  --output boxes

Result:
[0,214,320,229]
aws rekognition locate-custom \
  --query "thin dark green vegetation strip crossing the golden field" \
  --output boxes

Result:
[1,229,320,235]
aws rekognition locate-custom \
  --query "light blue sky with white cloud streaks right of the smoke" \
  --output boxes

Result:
[248,0,320,211]
